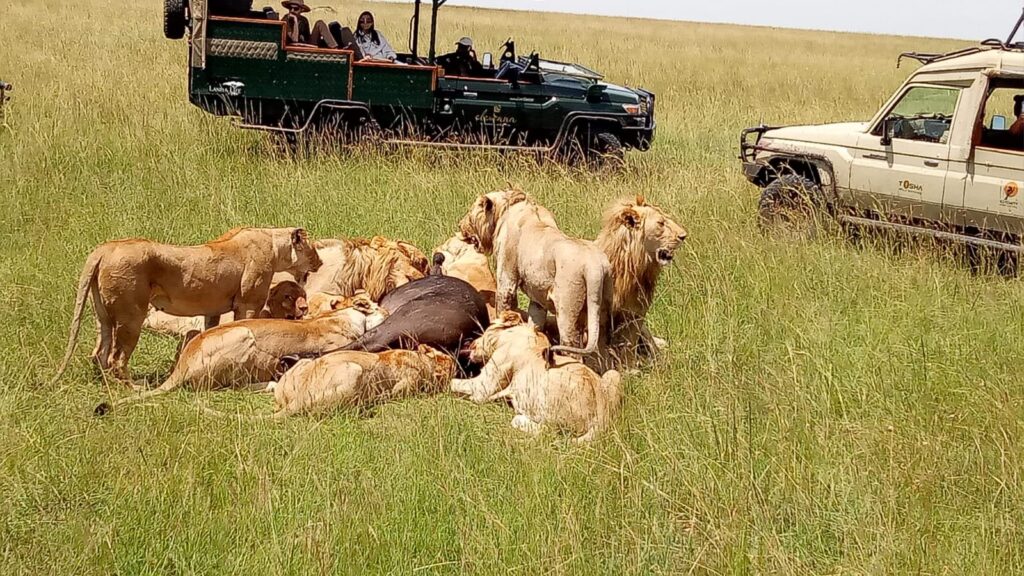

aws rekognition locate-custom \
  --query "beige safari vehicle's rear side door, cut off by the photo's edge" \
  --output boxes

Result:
[959,77,1024,235]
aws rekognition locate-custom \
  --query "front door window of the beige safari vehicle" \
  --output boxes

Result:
[876,86,961,143]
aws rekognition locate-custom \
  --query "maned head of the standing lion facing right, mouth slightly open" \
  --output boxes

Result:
[597,196,686,316]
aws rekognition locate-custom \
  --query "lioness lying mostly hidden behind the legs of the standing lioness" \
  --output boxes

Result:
[142,272,309,338]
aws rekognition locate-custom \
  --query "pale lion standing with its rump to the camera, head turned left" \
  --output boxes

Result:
[459,190,613,355]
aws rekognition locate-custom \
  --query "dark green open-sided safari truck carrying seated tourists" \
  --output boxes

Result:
[164,0,655,163]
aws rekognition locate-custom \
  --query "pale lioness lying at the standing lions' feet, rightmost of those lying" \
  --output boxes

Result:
[452,313,623,442]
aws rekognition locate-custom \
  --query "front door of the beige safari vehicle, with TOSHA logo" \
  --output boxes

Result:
[850,84,963,219]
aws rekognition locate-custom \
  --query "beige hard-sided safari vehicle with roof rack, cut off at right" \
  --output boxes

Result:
[740,7,1024,255]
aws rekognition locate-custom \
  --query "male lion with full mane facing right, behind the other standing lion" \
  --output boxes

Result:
[596,196,686,360]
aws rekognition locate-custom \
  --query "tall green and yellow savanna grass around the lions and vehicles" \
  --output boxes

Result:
[0,0,1024,574]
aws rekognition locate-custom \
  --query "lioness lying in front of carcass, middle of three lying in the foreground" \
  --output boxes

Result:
[273,345,455,418]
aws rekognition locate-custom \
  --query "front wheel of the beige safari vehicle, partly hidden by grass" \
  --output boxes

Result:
[758,174,831,240]
